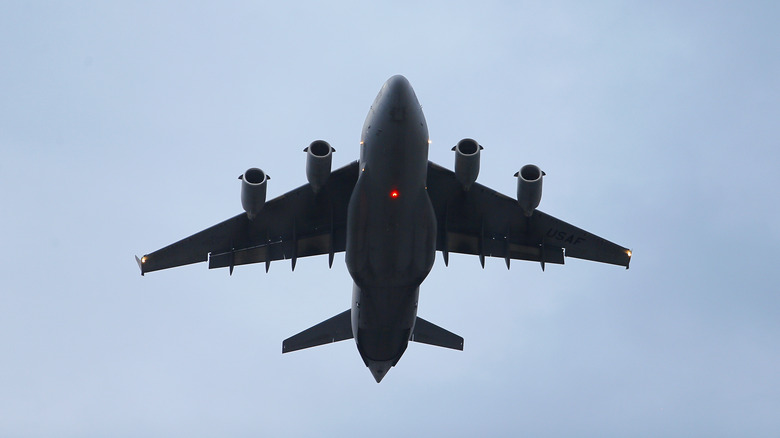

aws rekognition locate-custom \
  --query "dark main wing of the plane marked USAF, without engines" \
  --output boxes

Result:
[428,162,631,269]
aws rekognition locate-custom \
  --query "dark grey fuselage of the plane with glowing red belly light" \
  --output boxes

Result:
[346,76,436,381]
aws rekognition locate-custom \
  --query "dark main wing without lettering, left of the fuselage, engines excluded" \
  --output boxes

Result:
[136,161,358,275]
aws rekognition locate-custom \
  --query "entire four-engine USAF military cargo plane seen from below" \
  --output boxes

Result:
[136,75,631,383]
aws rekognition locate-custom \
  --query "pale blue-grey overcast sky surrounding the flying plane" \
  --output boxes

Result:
[0,1,780,437]
